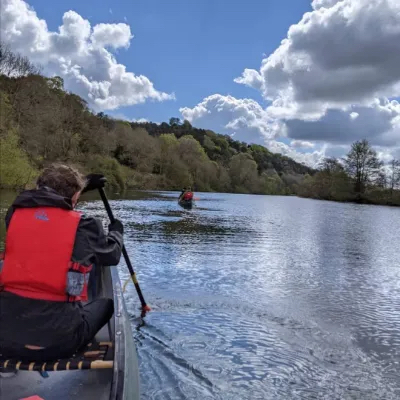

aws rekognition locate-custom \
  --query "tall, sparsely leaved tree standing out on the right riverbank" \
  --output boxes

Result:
[344,139,383,194]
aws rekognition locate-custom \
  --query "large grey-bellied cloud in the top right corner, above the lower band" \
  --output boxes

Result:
[235,0,400,119]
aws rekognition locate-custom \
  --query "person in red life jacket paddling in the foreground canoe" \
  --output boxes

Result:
[0,164,123,361]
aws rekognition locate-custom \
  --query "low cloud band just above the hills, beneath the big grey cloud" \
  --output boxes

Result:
[180,94,400,166]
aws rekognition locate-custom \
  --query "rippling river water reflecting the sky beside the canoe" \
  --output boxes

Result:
[2,192,400,400]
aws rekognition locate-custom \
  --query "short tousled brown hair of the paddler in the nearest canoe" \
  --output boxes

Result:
[36,163,86,199]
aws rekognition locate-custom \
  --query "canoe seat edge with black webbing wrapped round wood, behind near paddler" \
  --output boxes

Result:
[0,342,114,372]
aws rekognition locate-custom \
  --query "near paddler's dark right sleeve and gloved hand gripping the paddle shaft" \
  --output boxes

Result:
[72,216,123,266]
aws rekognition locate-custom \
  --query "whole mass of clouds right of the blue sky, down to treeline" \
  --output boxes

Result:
[183,0,400,165]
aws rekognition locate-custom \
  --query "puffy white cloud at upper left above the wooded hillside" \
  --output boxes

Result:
[0,0,174,111]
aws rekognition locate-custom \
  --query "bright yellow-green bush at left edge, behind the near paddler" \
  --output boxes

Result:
[0,131,37,188]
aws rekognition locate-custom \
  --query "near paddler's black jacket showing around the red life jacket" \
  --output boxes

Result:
[0,188,123,347]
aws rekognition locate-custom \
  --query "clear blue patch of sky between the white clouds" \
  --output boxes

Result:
[29,0,311,122]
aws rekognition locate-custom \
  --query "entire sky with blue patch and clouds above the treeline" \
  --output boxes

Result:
[0,0,400,166]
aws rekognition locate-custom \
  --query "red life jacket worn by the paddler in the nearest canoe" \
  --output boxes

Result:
[0,207,92,301]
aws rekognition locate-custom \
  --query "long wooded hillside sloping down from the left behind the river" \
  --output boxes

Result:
[0,45,313,194]
